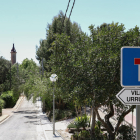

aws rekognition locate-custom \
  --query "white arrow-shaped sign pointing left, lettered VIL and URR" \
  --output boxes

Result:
[116,88,140,105]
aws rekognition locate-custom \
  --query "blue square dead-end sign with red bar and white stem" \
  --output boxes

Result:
[121,47,140,87]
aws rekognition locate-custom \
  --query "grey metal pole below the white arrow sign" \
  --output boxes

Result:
[136,105,140,140]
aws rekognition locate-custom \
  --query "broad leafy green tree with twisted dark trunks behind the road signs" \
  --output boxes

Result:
[49,23,139,140]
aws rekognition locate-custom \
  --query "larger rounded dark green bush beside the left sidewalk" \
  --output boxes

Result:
[1,91,19,108]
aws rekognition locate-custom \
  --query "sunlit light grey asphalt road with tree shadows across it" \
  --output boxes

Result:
[0,98,46,140]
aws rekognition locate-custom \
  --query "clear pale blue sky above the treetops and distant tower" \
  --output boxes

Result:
[0,0,140,64]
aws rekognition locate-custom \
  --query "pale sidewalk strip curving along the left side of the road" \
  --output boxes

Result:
[0,96,24,124]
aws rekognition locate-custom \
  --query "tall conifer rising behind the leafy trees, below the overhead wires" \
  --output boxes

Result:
[36,11,83,72]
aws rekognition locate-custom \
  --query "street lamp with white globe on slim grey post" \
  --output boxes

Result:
[50,74,58,135]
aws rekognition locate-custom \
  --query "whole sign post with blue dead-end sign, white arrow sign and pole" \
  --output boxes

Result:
[116,47,140,140]
